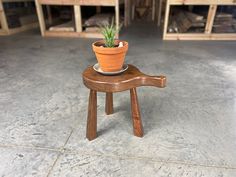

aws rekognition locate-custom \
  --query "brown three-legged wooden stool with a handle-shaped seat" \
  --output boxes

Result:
[83,65,166,140]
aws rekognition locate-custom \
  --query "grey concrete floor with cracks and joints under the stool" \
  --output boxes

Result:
[0,24,236,177]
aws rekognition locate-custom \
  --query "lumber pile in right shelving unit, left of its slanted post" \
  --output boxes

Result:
[168,10,206,33]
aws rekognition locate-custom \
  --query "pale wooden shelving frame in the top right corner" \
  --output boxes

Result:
[163,0,236,40]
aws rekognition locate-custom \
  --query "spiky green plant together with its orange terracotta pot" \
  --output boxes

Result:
[92,21,128,72]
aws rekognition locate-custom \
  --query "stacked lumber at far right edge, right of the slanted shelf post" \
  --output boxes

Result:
[213,13,236,33]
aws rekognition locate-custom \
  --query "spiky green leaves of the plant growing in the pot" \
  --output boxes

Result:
[100,19,120,48]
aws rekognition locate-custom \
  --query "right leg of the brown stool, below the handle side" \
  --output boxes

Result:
[130,88,143,137]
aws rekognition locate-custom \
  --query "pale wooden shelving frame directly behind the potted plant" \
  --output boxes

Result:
[35,0,130,38]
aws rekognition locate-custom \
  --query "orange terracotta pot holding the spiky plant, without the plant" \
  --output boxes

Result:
[92,40,128,72]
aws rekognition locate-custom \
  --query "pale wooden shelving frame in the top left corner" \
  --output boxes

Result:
[0,0,39,35]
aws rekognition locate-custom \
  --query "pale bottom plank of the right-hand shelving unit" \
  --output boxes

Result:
[164,33,236,40]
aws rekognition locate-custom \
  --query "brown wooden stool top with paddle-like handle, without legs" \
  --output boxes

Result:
[83,65,166,92]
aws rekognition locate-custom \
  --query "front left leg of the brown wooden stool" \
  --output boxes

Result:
[86,90,97,141]
